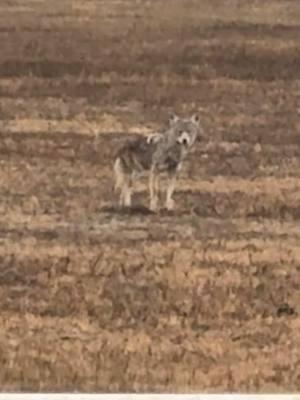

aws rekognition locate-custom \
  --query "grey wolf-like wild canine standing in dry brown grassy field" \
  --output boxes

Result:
[114,115,202,211]
